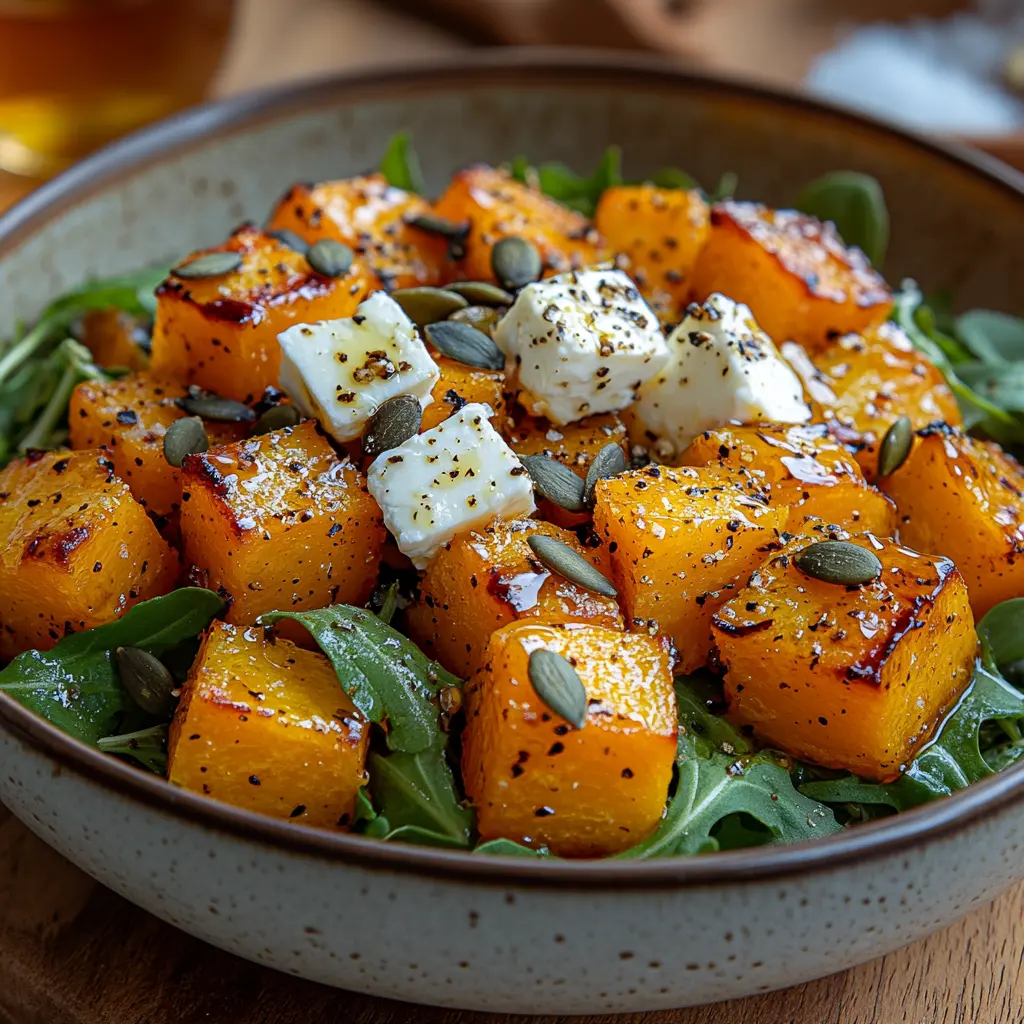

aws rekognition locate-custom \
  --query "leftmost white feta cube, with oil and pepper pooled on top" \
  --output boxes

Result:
[278,292,440,441]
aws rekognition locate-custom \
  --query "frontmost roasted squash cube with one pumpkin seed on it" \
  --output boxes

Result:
[463,622,678,857]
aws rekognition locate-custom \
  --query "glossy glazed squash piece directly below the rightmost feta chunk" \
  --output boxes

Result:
[682,423,896,537]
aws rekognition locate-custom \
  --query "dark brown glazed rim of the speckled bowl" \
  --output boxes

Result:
[0,48,1024,892]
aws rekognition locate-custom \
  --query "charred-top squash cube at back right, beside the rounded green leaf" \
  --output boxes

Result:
[693,201,893,353]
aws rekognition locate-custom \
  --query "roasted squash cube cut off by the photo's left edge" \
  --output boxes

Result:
[0,451,178,662]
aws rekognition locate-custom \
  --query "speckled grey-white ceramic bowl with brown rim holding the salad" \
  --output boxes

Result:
[0,51,1024,1014]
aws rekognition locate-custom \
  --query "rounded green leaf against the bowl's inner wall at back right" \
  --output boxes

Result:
[796,171,889,269]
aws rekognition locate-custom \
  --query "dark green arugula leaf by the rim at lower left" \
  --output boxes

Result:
[0,587,224,744]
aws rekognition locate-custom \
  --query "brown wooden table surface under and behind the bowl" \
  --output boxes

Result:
[0,0,1024,1024]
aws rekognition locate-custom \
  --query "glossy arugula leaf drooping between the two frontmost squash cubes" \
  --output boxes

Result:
[261,604,472,848]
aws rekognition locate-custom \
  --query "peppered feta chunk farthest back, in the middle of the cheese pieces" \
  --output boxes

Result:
[495,268,669,424]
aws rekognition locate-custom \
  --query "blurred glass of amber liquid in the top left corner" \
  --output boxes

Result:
[0,0,233,177]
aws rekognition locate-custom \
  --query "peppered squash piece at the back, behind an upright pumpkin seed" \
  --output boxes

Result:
[434,166,603,281]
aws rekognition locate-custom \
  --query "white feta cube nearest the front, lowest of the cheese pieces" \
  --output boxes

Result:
[367,402,535,569]
